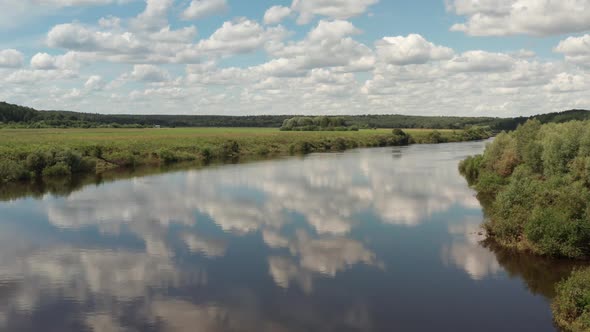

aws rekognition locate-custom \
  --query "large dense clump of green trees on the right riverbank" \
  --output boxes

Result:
[459,120,590,258]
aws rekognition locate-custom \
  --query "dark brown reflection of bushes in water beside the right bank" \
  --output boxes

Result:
[482,240,587,299]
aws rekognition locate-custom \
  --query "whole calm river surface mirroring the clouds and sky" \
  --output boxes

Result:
[0,142,584,332]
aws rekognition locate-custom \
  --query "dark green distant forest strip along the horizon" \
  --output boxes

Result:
[0,102,590,131]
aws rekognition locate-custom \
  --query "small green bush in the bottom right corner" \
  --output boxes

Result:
[551,268,590,332]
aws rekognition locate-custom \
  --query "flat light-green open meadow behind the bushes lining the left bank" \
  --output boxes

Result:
[0,128,472,159]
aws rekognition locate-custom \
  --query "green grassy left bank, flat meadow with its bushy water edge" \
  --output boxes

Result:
[0,128,490,183]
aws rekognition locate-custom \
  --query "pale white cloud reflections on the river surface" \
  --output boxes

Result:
[0,144,499,331]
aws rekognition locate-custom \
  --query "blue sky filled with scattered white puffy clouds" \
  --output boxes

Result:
[0,0,590,117]
